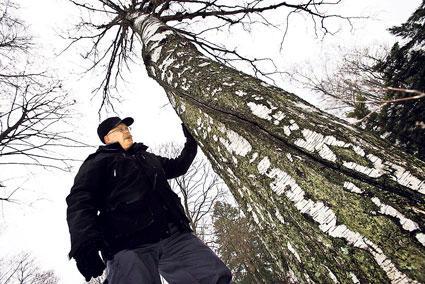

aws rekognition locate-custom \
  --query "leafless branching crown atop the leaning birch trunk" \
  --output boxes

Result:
[65,0,357,111]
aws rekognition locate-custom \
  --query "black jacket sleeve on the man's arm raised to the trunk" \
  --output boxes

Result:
[159,139,198,179]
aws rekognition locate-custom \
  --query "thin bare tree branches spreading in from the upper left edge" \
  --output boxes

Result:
[0,1,89,202]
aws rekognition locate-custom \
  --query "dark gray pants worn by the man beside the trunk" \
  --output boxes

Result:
[107,227,232,284]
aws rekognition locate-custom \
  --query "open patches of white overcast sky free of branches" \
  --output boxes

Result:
[0,0,420,284]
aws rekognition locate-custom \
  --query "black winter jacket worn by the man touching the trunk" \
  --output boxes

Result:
[66,139,197,258]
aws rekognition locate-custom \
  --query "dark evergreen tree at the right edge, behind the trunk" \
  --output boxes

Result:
[366,1,425,160]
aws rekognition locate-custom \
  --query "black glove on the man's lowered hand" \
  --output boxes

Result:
[75,246,106,282]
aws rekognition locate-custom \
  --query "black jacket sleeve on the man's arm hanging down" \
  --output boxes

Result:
[66,158,104,258]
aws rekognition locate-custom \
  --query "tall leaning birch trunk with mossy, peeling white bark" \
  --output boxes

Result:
[133,15,425,283]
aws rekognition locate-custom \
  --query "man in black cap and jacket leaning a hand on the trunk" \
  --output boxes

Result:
[66,117,231,284]
